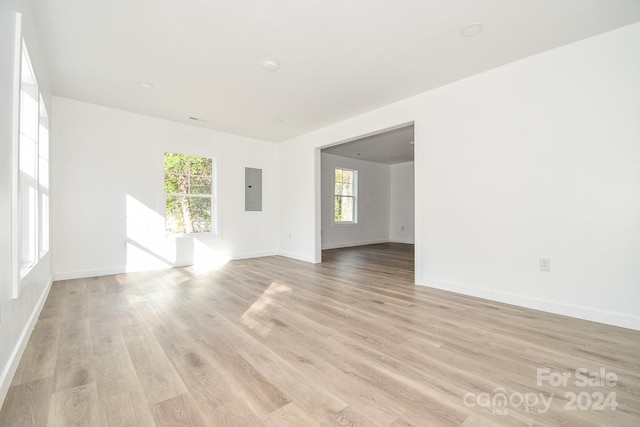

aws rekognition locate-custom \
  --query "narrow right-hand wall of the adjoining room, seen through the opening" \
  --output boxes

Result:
[389,162,415,244]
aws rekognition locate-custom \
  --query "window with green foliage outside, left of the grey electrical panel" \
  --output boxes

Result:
[164,153,215,234]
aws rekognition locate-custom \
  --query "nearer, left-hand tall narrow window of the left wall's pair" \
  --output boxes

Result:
[18,42,40,274]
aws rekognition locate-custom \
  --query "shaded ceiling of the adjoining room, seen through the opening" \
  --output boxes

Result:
[322,125,414,165]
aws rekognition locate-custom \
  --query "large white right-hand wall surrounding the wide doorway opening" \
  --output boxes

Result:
[280,24,640,329]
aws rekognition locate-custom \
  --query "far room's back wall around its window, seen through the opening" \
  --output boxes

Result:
[322,153,390,249]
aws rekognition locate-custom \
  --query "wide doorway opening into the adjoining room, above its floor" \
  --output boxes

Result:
[320,123,415,270]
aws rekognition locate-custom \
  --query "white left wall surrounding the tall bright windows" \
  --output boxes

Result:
[0,0,55,408]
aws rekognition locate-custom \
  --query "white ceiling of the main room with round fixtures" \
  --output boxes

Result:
[32,0,640,141]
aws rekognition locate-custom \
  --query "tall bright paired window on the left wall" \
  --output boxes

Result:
[17,40,49,277]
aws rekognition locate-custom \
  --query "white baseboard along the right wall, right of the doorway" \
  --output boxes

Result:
[416,277,640,330]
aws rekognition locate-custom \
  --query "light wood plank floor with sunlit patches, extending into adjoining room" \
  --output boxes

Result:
[0,244,640,427]
